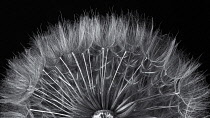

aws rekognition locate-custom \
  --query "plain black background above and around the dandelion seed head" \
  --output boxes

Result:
[0,0,210,81]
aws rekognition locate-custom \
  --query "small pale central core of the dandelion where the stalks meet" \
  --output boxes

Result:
[92,110,114,118]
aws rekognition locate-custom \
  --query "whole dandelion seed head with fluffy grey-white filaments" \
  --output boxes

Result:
[0,15,209,118]
